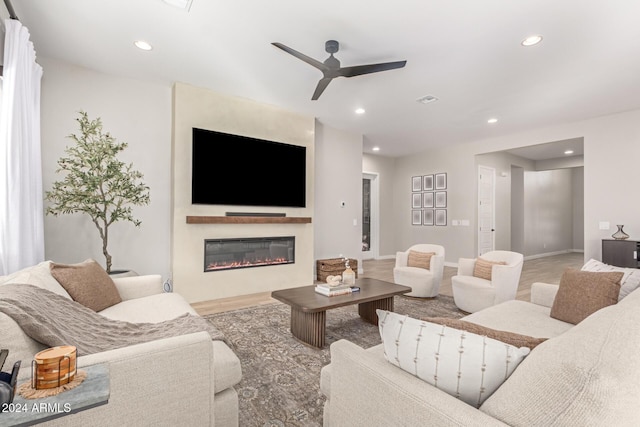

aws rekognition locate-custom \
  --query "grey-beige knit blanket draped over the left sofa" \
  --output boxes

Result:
[0,284,224,355]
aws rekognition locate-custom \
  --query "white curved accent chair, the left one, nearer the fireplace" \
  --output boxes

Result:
[393,244,444,298]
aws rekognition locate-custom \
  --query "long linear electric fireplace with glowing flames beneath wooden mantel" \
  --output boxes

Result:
[204,236,296,272]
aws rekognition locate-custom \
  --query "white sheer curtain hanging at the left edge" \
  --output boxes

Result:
[0,19,44,275]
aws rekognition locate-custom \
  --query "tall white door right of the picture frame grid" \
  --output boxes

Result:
[478,166,496,256]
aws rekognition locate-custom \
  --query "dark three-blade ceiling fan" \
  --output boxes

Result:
[271,40,407,101]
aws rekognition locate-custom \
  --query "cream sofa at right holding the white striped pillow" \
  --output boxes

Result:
[320,283,640,427]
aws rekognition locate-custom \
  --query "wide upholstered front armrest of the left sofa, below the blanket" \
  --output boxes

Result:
[72,332,214,426]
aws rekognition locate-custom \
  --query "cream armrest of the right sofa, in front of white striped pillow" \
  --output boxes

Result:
[325,340,505,426]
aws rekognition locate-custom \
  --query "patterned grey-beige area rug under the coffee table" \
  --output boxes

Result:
[206,296,465,427]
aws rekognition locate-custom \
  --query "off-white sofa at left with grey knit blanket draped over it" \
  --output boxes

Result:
[0,261,242,426]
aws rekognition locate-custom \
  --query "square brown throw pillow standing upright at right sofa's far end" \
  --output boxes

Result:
[550,268,624,325]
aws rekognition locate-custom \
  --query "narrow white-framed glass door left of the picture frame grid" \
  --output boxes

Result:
[361,173,379,259]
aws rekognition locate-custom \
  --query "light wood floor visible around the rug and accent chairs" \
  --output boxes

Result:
[192,252,584,316]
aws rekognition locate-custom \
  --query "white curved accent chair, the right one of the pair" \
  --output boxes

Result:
[451,251,524,313]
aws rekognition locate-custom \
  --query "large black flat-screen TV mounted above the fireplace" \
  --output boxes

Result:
[191,128,307,208]
